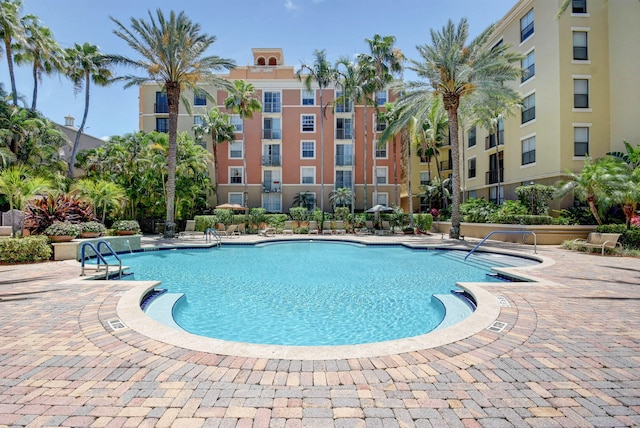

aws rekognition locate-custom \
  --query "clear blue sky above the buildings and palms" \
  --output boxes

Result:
[0,0,516,138]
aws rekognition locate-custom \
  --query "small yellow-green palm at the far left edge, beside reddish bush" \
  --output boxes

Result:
[0,165,53,237]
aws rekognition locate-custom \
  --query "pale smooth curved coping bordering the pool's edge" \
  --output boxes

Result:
[116,239,555,360]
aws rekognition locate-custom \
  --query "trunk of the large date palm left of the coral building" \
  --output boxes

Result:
[165,82,180,232]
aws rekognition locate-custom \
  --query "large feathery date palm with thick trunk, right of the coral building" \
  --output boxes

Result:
[409,18,522,239]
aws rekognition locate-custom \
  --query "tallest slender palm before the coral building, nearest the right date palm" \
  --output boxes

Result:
[358,34,404,208]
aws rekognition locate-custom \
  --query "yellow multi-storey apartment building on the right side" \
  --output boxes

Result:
[461,0,640,203]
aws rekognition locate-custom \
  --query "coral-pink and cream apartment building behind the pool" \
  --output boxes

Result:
[140,48,401,213]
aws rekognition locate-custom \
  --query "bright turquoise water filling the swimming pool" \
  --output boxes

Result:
[117,241,512,346]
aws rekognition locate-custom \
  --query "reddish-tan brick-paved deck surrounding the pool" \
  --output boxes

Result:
[0,235,640,428]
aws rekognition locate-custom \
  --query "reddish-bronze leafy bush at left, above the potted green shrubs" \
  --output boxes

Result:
[24,193,96,234]
